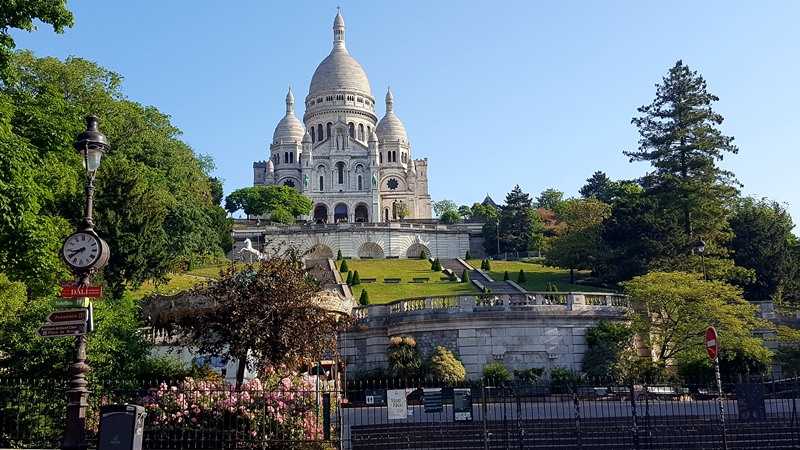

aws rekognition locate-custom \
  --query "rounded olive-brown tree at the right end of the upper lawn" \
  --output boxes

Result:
[545,197,611,284]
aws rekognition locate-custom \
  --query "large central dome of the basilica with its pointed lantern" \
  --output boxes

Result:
[308,13,372,97]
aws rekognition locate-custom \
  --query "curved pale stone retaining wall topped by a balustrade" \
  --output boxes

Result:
[339,292,631,379]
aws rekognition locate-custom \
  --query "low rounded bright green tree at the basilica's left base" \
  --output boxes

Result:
[225,186,311,225]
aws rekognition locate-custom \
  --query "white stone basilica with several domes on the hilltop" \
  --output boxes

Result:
[253,13,431,224]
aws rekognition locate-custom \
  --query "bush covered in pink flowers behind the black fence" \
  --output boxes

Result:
[141,369,322,443]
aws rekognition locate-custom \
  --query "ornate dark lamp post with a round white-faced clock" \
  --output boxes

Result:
[61,116,109,450]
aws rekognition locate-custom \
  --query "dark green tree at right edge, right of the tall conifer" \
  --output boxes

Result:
[728,197,800,301]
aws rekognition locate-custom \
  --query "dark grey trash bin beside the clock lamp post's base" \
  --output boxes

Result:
[97,404,146,450]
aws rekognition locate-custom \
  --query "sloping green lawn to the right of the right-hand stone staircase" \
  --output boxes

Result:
[467,259,614,292]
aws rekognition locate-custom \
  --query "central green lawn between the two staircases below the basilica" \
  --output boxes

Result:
[337,259,478,304]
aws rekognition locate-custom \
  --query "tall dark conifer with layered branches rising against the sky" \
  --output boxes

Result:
[623,60,739,236]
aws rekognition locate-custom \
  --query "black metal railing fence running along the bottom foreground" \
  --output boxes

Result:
[0,378,800,450]
